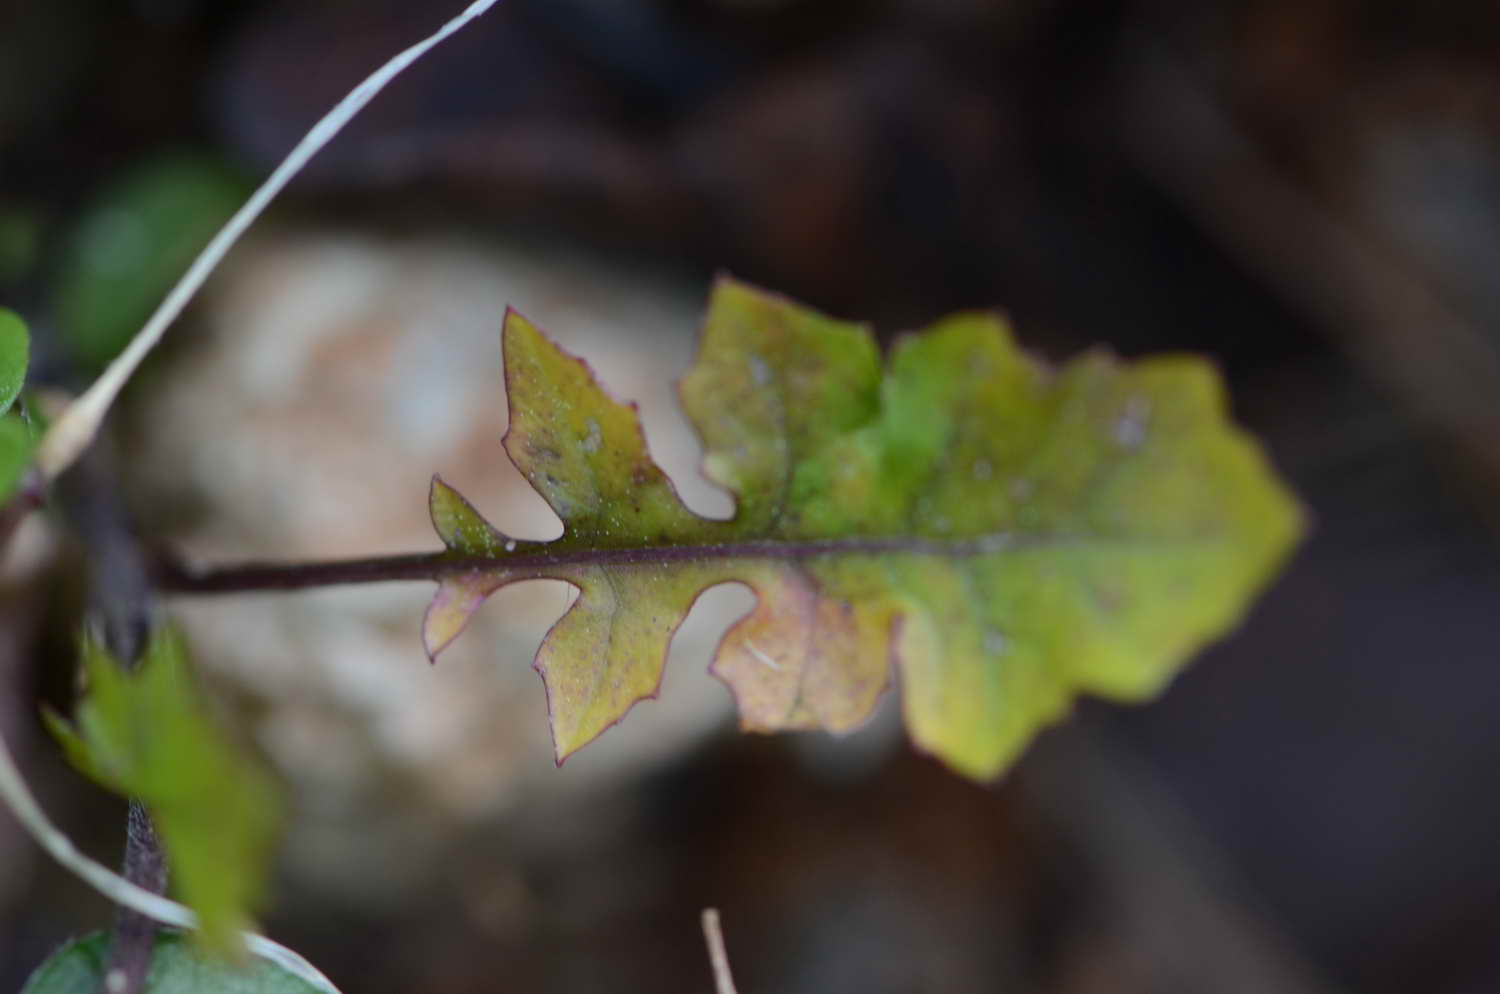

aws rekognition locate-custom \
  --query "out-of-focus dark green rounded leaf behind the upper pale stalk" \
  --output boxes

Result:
[56,156,248,366]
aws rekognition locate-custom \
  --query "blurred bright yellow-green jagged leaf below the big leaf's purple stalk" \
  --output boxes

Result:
[44,628,281,949]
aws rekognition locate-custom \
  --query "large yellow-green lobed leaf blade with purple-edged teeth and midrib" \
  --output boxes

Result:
[425,279,1302,778]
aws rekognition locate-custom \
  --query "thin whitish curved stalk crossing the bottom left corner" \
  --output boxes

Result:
[0,739,339,994]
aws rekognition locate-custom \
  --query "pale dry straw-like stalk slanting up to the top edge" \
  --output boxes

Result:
[36,0,495,480]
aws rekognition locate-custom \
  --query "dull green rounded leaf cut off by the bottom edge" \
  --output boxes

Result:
[21,933,323,994]
